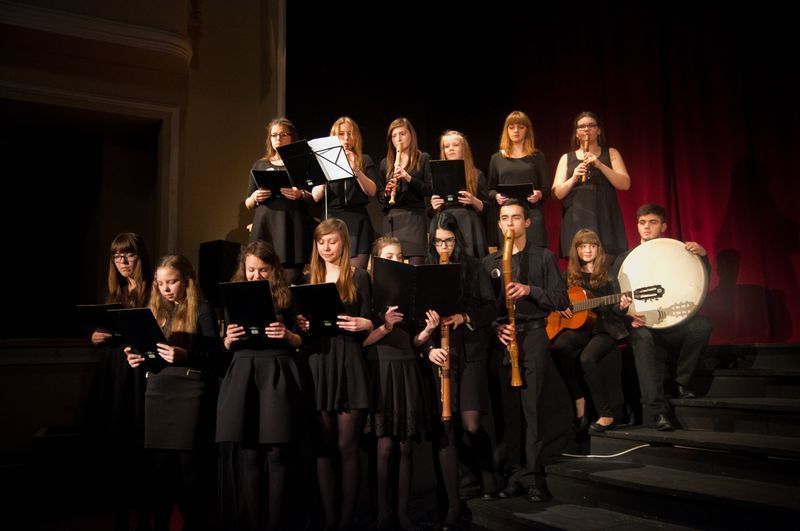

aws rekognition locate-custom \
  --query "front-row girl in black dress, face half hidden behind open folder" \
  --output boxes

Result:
[364,236,436,529]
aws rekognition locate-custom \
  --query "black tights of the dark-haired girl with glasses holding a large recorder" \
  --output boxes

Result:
[436,411,490,524]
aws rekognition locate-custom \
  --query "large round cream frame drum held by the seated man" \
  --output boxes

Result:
[617,238,708,328]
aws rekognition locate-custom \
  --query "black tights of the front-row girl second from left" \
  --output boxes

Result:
[153,450,207,531]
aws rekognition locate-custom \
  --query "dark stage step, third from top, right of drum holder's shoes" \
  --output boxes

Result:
[670,397,800,436]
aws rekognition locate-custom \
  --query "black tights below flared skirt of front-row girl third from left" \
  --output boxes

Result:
[241,446,286,530]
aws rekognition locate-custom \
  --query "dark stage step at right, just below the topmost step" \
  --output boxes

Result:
[692,368,800,399]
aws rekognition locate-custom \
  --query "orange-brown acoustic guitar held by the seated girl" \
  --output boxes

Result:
[547,285,664,339]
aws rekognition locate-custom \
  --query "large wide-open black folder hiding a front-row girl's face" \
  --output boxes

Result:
[372,258,461,323]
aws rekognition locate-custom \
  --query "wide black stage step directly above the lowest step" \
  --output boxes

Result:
[547,456,800,529]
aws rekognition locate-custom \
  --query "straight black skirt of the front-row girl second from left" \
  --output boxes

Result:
[144,367,216,450]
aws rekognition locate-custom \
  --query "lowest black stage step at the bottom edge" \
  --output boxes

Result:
[467,498,693,531]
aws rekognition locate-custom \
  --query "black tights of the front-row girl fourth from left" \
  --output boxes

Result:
[317,410,364,529]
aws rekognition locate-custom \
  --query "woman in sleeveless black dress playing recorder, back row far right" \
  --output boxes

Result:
[553,112,631,263]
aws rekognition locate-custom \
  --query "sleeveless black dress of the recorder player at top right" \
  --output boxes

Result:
[560,150,628,257]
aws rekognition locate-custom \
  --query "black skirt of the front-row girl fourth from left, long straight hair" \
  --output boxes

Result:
[308,334,369,411]
